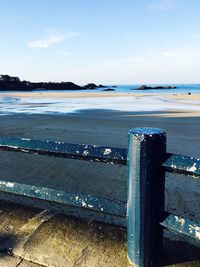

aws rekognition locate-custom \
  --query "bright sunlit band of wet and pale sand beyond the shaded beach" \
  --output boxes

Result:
[0,91,200,117]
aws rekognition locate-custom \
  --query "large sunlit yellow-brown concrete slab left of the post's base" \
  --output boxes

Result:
[14,215,130,267]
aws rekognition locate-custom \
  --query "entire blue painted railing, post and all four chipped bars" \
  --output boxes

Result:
[0,128,200,267]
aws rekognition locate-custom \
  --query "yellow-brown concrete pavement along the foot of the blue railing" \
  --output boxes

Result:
[0,201,200,267]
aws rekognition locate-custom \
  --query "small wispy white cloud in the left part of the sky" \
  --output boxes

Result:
[28,32,80,48]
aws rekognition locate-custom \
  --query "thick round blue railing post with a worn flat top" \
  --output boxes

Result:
[127,128,166,267]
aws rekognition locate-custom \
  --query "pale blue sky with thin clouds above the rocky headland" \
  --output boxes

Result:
[0,0,200,85]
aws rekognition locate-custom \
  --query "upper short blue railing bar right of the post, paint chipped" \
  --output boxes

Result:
[162,153,200,178]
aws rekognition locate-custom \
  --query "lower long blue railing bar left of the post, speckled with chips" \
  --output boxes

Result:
[0,180,126,218]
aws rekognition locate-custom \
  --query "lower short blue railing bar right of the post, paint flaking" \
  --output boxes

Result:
[160,214,200,241]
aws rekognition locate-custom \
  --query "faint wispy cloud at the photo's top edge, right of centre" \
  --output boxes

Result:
[147,0,179,11]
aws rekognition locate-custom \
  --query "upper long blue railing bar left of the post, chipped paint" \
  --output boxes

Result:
[0,137,127,165]
